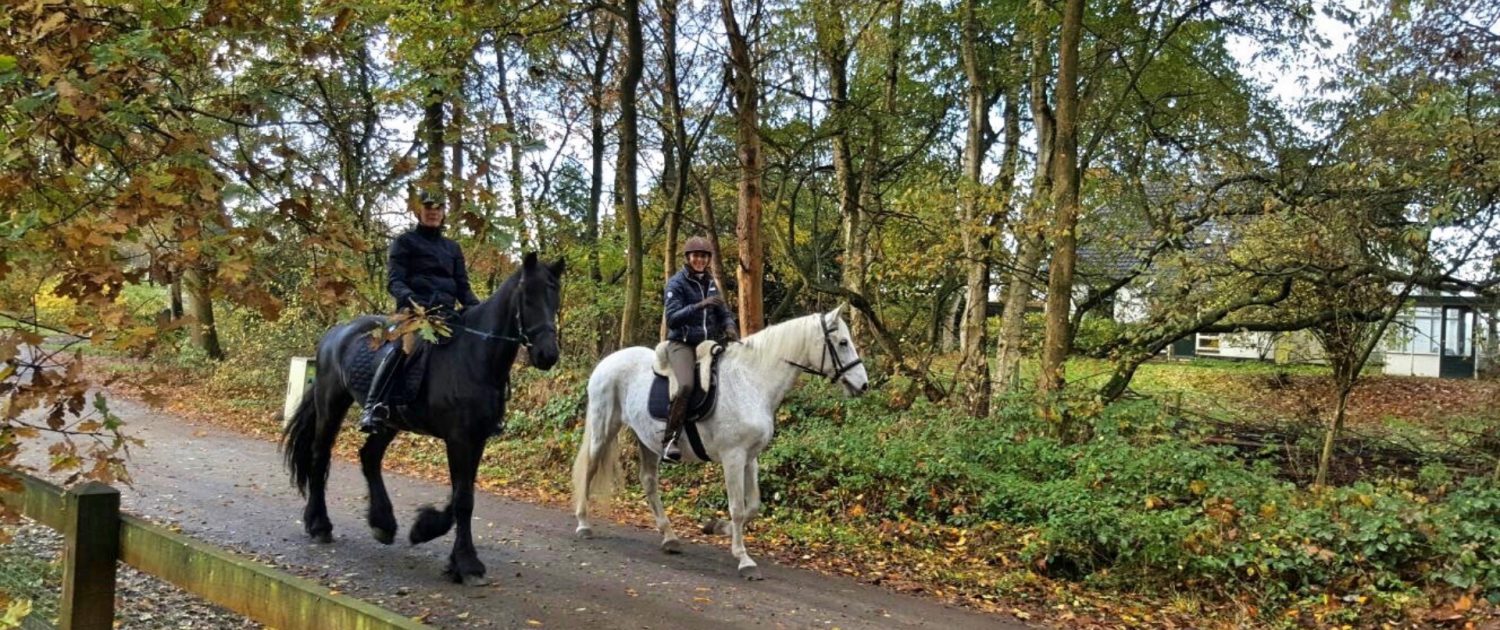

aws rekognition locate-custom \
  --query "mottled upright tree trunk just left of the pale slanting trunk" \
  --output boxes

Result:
[957,0,990,417]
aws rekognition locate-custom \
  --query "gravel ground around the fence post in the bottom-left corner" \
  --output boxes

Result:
[0,521,261,630]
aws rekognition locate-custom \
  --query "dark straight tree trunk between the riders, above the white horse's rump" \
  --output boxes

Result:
[618,0,645,348]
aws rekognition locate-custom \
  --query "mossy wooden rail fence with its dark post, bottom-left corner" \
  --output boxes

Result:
[0,468,426,630]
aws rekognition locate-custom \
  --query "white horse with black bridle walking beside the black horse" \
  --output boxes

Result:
[573,306,870,579]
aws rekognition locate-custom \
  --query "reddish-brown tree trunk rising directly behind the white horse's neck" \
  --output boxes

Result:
[720,0,765,338]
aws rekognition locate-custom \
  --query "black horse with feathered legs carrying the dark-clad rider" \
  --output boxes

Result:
[282,254,564,585]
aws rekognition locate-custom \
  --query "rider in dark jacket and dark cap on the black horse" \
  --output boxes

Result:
[360,189,479,434]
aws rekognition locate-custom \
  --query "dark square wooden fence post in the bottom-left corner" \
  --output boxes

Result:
[57,482,120,630]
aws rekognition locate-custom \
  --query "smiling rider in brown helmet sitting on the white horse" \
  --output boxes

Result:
[662,236,740,462]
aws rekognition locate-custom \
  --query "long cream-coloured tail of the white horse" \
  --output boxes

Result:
[573,378,626,515]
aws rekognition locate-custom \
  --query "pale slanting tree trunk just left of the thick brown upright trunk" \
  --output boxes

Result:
[995,0,1056,392]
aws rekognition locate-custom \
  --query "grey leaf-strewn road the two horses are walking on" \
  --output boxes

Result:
[17,399,1025,630]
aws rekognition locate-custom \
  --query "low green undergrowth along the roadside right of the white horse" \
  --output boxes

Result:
[761,386,1500,606]
